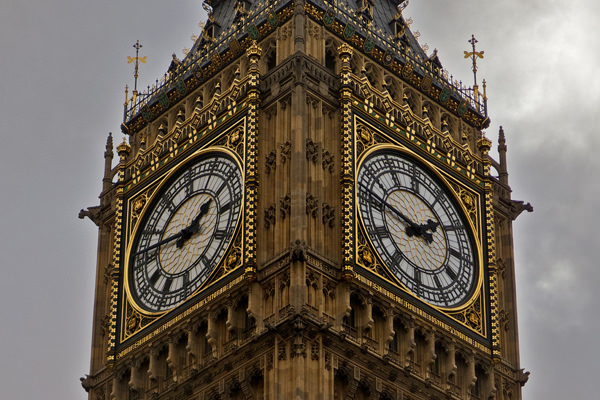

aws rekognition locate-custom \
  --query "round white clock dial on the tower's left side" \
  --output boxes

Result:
[128,152,243,312]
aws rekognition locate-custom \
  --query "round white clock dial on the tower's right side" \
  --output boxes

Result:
[357,150,478,307]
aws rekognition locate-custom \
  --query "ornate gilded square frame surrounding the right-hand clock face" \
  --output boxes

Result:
[347,112,492,340]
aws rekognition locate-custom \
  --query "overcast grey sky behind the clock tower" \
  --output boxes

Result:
[0,0,600,400]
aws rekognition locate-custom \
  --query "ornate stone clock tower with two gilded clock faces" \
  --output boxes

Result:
[80,0,531,400]
